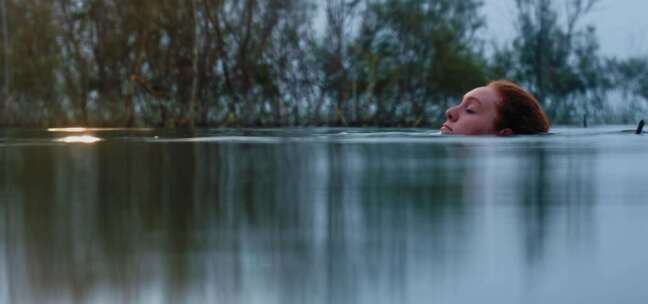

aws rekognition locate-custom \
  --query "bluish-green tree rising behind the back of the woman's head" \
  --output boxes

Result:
[494,0,610,122]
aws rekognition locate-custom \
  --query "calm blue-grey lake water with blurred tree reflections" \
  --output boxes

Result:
[0,126,648,304]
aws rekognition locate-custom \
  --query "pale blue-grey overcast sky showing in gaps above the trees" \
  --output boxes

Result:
[484,0,648,57]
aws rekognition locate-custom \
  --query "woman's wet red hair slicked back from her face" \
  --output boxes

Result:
[488,80,549,134]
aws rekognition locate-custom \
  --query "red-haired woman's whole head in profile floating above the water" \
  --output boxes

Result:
[441,80,549,135]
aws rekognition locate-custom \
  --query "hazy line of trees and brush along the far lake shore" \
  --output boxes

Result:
[0,0,648,127]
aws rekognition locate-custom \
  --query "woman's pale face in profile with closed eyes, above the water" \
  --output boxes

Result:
[441,87,500,135]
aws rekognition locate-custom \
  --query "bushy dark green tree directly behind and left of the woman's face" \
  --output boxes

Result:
[344,0,485,125]
